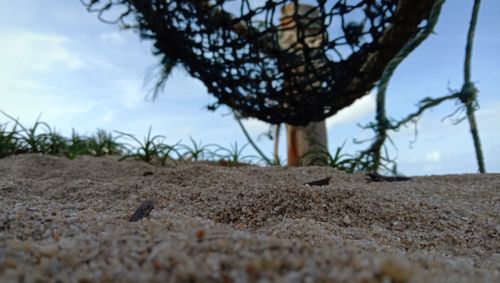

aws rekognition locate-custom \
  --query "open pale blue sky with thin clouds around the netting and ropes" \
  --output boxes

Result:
[0,0,500,175]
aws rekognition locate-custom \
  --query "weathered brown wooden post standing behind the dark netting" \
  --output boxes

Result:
[279,3,328,166]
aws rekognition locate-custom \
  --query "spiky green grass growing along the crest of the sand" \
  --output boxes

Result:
[0,110,369,172]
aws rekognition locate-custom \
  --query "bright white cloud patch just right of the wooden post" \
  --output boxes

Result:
[326,93,375,129]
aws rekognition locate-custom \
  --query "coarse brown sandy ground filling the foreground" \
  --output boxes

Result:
[0,155,500,282]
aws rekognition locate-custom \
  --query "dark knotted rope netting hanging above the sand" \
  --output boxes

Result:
[82,0,435,125]
